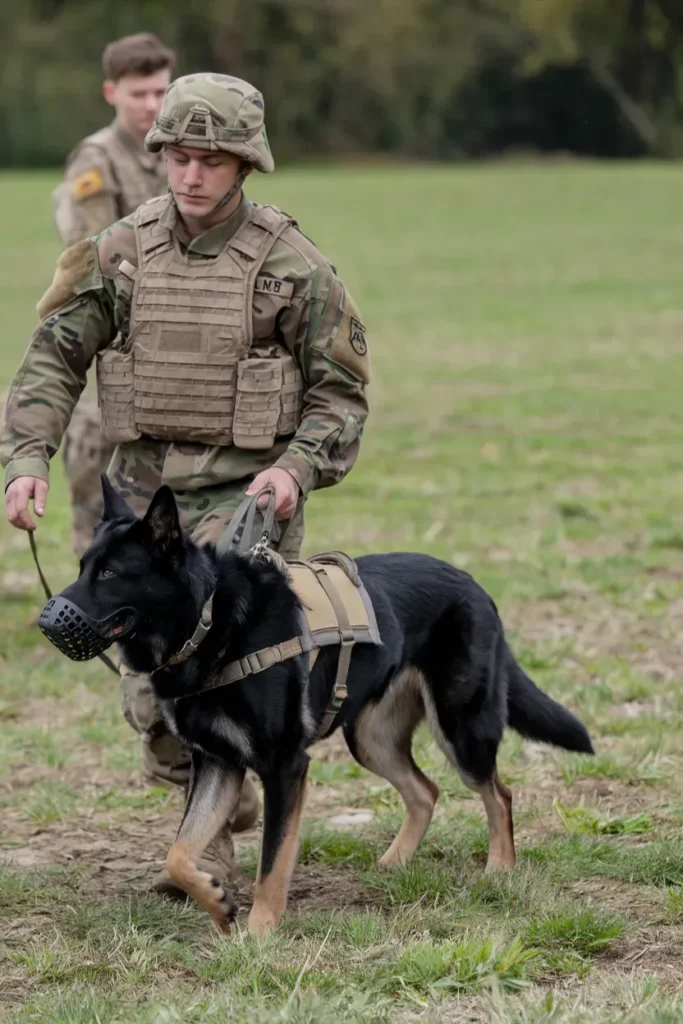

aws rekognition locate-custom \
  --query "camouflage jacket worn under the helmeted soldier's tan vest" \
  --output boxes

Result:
[1,190,370,509]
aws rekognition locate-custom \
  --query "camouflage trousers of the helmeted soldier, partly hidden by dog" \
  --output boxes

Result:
[109,440,304,782]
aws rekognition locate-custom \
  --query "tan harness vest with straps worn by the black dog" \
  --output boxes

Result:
[174,551,382,740]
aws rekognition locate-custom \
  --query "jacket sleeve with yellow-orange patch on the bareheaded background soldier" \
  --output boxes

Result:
[52,143,120,246]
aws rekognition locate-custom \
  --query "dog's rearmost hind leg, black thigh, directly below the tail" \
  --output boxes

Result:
[423,682,515,872]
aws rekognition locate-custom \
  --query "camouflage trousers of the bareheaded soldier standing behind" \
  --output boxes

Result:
[61,395,114,556]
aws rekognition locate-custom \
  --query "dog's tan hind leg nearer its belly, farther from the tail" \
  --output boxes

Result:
[346,670,438,866]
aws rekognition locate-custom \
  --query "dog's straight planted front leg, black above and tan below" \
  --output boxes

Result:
[248,753,310,935]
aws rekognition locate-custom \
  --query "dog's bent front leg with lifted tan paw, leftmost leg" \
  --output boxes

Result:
[166,752,245,932]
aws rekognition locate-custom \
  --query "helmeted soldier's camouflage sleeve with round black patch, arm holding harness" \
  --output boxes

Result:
[275,258,370,494]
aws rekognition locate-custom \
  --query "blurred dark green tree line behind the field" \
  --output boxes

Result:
[0,0,683,166]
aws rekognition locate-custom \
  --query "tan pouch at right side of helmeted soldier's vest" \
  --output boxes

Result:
[232,353,303,451]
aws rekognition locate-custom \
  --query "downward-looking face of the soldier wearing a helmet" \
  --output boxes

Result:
[166,145,248,220]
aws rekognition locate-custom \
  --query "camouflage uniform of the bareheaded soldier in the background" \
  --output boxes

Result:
[52,120,167,555]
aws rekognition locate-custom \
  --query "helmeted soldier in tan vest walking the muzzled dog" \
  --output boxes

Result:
[1,74,370,893]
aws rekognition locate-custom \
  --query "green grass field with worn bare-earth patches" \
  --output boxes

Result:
[0,164,683,1024]
